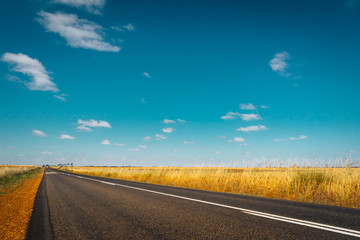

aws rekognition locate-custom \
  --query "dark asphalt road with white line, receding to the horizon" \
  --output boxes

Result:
[27,169,360,240]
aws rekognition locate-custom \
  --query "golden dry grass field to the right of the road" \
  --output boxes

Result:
[54,167,360,208]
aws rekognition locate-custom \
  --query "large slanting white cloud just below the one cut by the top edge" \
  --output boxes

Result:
[38,11,120,52]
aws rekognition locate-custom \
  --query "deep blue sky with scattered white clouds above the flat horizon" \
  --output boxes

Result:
[0,0,360,166]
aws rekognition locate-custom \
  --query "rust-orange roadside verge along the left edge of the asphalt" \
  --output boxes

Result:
[0,167,43,240]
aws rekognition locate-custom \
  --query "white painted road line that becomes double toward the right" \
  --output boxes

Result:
[60,173,360,238]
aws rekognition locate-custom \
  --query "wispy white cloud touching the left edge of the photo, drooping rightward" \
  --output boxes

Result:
[1,53,59,92]
